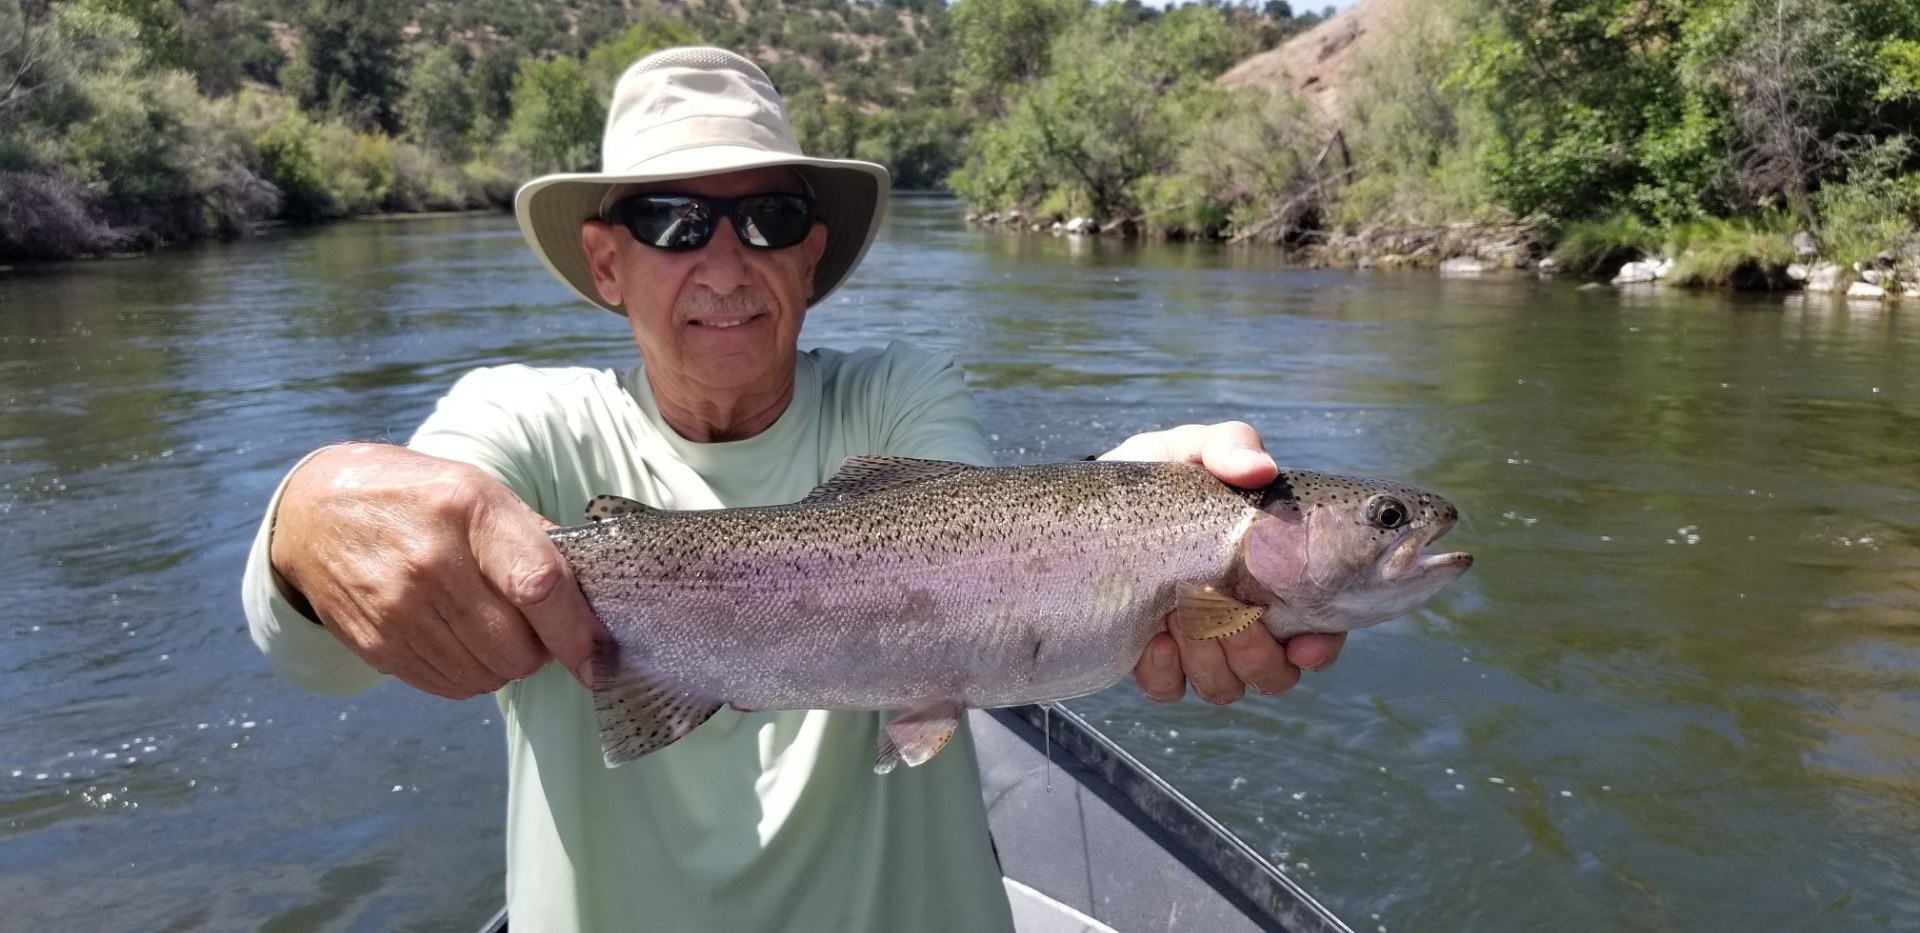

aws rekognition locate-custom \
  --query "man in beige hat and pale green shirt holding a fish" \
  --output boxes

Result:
[246,48,1340,931]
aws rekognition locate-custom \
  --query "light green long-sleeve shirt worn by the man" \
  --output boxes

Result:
[244,344,1012,933]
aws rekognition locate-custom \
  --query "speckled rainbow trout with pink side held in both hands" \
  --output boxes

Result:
[551,457,1473,772]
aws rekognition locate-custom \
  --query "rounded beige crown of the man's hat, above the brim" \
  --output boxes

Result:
[601,48,801,173]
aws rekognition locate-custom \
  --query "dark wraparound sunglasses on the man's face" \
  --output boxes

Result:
[607,194,814,251]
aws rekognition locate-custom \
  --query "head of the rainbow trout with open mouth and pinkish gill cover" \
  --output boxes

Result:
[1242,470,1473,637]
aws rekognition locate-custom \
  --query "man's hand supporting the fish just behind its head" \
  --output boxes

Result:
[1100,420,1346,703]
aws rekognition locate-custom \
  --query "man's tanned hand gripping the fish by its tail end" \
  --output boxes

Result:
[271,443,599,699]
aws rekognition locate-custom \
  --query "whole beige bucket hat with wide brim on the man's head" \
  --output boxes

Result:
[513,48,887,313]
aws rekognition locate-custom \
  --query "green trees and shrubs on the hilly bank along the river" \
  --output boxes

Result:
[0,0,1920,299]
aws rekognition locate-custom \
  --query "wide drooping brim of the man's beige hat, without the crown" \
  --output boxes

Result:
[513,146,887,315]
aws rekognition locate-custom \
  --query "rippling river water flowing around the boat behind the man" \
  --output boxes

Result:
[0,198,1920,933]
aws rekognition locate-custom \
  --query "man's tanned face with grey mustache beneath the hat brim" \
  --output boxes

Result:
[580,169,828,394]
